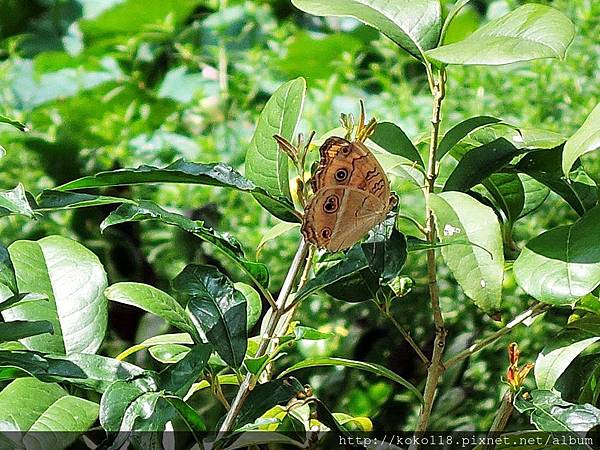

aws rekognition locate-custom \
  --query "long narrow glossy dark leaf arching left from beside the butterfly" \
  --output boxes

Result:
[56,158,298,221]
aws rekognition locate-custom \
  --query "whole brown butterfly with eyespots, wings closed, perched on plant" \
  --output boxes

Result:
[302,137,397,252]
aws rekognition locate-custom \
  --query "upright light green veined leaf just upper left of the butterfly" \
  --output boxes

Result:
[246,77,306,221]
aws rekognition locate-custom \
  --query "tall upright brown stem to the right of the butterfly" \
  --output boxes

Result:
[411,67,446,442]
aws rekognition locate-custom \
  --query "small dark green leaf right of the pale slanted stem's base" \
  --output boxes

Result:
[235,377,304,429]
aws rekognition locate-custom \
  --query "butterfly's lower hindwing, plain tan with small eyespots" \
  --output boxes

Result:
[302,186,392,252]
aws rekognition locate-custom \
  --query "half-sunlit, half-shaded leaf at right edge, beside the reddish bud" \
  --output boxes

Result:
[535,330,600,390]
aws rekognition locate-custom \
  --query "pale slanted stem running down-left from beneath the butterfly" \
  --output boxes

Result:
[219,239,309,435]
